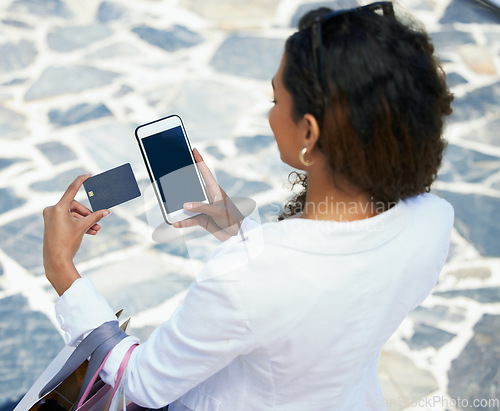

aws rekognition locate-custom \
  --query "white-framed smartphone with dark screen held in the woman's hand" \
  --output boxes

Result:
[135,115,209,224]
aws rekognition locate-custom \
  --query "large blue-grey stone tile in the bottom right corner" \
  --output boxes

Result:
[448,314,500,411]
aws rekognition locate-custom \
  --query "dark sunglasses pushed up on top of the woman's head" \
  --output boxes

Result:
[303,1,394,110]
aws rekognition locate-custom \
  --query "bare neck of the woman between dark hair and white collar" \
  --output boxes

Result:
[301,164,377,221]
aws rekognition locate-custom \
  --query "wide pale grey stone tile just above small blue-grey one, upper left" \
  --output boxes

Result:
[24,66,118,101]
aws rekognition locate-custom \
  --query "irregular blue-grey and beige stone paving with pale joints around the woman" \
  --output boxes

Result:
[0,0,500,410]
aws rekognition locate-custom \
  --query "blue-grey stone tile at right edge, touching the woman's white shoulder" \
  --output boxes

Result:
[433,190,500,257]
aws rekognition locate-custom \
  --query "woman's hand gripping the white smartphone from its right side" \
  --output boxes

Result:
[174,149,245,241]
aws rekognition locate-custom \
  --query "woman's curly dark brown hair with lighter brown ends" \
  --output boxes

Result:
[279,7,453,219]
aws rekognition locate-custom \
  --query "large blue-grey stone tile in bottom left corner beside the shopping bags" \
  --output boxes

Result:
[0,294,64,406]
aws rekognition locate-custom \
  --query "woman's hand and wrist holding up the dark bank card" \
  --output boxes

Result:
[43,174,110,295]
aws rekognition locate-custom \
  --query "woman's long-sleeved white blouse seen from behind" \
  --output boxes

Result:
[56,194,453,411]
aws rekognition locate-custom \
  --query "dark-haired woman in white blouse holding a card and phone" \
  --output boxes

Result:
[44,3,453,410]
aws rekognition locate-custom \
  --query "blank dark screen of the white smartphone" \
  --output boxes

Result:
[142,126,206,214]
